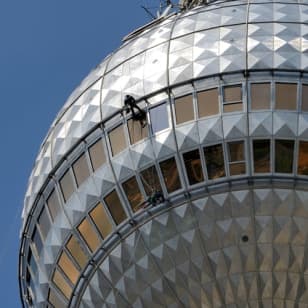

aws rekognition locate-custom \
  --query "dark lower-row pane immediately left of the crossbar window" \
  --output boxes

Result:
[204,144,226,180]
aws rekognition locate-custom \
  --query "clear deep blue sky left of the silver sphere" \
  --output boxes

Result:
[0,0,159,308]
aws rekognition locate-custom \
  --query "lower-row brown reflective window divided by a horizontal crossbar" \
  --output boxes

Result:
[228,141,246,175]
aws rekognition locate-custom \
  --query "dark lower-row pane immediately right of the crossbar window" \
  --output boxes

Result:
[253,140,271,173]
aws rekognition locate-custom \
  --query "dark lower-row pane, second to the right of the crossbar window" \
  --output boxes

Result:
[275,140,294,173]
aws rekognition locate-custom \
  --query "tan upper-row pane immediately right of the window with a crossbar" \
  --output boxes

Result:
[250,83,271,110]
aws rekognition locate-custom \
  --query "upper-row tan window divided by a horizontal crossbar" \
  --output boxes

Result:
[223,85,243,112]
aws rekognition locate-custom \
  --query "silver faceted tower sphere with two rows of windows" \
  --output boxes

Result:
[19,0,308,308]
